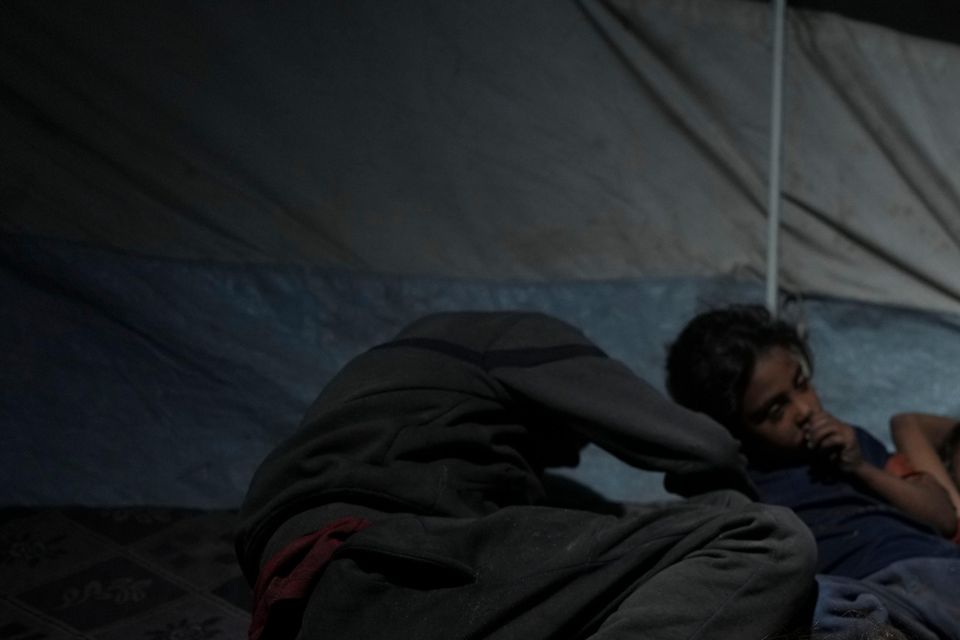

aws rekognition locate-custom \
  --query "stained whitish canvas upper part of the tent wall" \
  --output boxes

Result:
[0,0,960,312]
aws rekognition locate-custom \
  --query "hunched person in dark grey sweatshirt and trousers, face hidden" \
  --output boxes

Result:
[237,312,815,640]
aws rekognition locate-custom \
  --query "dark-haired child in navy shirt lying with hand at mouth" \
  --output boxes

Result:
[667,306,960,638]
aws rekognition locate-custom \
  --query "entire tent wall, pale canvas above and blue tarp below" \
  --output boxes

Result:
[0,0,960,507]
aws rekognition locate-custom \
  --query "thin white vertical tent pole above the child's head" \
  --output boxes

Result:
[767,0,787,315]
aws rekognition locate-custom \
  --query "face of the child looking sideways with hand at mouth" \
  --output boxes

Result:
[741,347,821,459]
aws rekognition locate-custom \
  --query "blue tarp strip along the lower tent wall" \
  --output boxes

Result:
[7,235,960,507]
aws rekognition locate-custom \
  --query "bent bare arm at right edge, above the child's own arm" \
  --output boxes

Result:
[890,413,960,512]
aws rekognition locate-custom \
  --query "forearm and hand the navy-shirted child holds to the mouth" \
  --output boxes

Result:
[808,412,957,537]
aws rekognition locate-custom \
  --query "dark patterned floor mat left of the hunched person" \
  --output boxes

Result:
[0,508,250,640]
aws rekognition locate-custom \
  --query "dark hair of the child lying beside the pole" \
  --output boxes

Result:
[667,305,813,434]
